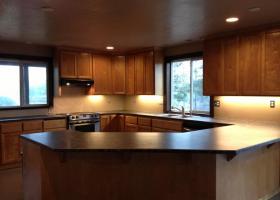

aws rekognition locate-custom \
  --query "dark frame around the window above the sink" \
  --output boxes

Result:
[163,52,214,117]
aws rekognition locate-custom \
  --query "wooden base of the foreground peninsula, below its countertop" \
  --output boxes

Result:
[23,140,279,200]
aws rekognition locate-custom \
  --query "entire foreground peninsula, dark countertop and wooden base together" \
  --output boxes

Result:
[21,125,280,200]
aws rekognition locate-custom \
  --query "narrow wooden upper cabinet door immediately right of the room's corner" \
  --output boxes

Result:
[125,55,135,95]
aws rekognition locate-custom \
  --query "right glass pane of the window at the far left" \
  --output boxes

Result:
[28,66,47,104]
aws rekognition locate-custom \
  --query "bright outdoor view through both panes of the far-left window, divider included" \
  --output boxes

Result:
[0,60,48,108]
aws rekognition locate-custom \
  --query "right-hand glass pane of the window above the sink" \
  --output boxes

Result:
[192,60,210,113]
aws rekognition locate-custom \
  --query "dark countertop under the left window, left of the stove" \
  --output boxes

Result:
[0,115,66,122]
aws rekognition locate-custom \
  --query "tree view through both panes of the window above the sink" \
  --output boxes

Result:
[170,59,210,114]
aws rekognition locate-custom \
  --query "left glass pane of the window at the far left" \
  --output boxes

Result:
[0,64,20,107]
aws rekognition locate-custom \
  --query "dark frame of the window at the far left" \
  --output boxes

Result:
[0,54,54,110]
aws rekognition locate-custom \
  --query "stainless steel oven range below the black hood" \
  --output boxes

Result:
[68,113,100,132]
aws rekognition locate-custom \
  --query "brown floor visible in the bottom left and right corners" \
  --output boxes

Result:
[0,168,280,200]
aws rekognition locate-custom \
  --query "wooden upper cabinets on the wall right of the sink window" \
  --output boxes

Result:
[203,27,280,96]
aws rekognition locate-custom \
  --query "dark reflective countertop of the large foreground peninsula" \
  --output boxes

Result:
[21,125,280,155]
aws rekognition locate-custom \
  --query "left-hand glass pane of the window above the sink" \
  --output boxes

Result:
[171,60,190,112]
